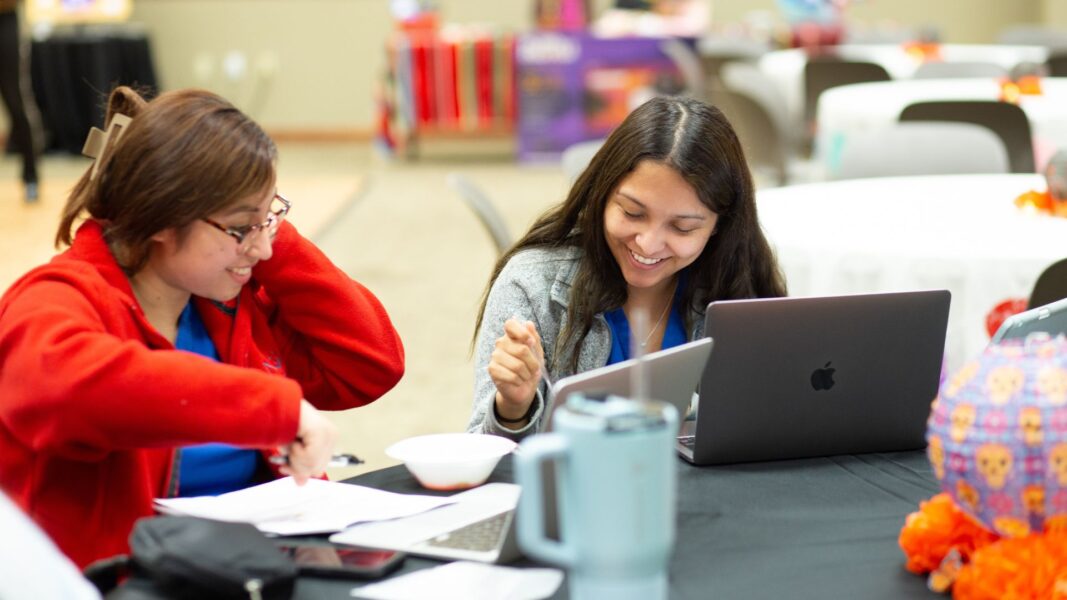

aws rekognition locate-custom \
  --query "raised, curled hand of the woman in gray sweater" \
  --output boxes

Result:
[489,318,544,428]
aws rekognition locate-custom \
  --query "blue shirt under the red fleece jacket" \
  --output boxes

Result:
[174,302,259,496]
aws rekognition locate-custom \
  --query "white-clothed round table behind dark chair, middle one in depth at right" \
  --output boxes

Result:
[815,77,1067,173]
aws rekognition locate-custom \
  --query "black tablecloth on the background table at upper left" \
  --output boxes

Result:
[30,30,158,154]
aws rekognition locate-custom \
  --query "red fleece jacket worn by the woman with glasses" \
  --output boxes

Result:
[0,221,403,566]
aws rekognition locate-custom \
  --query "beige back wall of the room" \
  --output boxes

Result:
[0,0,1067,135]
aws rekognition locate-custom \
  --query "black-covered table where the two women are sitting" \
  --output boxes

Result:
[294,452,942,600]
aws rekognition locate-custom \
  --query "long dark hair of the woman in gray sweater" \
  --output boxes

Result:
[475,97,785,370]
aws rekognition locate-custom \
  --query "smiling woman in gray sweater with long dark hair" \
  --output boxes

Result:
[467,97,785,439]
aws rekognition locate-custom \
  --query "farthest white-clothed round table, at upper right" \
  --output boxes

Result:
[759,44,1049,132]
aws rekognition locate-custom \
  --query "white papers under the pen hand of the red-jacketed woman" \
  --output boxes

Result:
[155,477,455,535]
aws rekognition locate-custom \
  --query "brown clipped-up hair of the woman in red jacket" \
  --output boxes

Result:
[55,86,277,273]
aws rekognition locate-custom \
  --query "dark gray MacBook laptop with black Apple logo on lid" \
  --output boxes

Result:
[679,290,950,464]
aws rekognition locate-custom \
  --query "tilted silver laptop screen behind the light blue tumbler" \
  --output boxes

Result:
[542,337,712,431]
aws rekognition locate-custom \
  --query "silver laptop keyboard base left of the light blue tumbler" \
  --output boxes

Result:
[330,484,520,563]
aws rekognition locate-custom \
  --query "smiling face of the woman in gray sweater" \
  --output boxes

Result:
[604,160,718,290]
